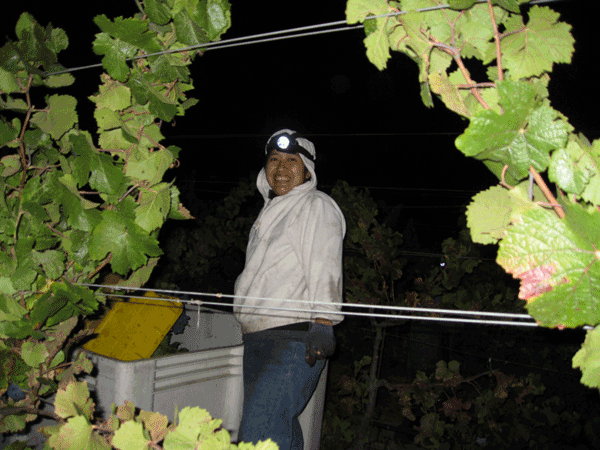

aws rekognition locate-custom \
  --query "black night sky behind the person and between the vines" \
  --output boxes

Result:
[0,0,600,246]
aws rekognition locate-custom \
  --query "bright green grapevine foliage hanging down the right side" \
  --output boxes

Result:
[346,0,600,388]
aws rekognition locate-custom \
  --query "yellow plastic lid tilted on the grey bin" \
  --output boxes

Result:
[83,292,183,361]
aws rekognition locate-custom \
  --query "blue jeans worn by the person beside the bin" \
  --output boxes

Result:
[238,337,325,450]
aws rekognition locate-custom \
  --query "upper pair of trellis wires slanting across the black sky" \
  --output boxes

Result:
[46,0,564,76]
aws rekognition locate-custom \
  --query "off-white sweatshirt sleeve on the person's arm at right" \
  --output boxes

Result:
[292,194,346,324]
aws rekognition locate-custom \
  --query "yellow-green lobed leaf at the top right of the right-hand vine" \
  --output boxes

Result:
[502,6,575,80]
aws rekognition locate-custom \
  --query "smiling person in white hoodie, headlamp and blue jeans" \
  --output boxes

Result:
[234,129,346,450]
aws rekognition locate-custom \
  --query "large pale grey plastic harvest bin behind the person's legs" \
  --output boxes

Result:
[85,304,327,450]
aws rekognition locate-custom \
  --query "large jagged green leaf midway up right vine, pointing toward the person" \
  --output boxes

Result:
[456,81,567,180]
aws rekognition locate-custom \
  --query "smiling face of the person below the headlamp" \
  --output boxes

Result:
[265,150,310,195]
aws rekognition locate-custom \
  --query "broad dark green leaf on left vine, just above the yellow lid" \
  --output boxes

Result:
[89,210,162,275]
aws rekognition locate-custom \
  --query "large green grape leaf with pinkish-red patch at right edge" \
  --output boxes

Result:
[497,198,600,327]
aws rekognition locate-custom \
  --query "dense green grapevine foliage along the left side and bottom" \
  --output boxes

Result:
[0,0,276,450]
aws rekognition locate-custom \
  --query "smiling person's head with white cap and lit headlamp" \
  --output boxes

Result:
[265,130,315,195]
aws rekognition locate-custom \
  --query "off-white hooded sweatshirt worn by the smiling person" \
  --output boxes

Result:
[234,134,346,333]
